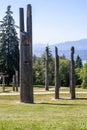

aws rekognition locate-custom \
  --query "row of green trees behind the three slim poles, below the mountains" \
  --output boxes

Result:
[33,48,84,87]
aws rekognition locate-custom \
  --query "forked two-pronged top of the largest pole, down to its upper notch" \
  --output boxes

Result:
[19,4,32,45]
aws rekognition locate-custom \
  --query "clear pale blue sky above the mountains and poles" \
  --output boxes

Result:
[0,0,87,44]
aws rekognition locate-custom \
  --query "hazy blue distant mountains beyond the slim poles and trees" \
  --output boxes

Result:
[33,39,87,60]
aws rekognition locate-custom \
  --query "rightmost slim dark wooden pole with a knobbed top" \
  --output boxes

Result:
[70,47,75,99]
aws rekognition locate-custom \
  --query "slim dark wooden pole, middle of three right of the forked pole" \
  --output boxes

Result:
[55,47,60,99]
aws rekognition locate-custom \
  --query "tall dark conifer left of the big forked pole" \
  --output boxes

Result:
[0,5,19,84]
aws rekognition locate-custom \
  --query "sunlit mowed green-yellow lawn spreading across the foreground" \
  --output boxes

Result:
[0,89,87,130]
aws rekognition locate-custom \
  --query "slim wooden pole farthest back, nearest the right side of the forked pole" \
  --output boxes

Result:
[45,47,49,91]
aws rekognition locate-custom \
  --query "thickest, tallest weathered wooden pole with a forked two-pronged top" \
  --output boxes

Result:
[20,4,34,103]
